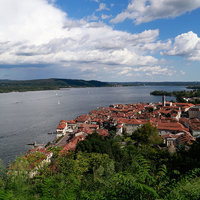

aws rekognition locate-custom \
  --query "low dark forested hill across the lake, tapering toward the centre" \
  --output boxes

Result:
[0,78,111,93]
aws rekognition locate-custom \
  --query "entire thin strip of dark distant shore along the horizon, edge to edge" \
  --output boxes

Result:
[0,78,200,93]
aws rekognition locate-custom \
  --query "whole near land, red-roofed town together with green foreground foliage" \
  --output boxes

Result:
[0,97,200,200]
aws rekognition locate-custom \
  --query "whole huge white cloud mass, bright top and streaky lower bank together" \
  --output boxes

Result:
[0,0,176,79]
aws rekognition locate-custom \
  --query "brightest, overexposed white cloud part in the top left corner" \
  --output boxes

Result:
[0,0,67,44]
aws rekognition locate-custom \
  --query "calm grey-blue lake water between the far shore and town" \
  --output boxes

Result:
[0,86,185,164]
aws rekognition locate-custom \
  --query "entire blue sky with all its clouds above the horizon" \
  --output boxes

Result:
[0,0,200,82]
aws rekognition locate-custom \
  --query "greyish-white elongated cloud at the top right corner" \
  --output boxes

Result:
[111,0,200,24]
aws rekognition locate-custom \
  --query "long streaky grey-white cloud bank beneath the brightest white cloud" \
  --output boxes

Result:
[0,28,157,66]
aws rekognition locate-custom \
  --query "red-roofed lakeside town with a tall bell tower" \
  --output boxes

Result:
[24,96,200,172]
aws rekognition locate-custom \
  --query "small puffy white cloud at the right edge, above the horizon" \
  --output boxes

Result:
[164,31,200,61]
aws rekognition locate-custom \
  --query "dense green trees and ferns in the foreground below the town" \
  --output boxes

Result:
[0,124,200,200]
